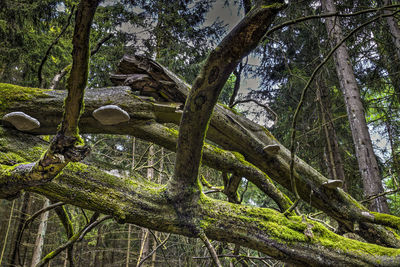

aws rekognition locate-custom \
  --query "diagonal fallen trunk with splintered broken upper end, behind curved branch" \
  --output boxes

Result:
[111,56,400,247]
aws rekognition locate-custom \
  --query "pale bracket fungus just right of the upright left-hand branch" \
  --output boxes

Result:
[93,105,130,125]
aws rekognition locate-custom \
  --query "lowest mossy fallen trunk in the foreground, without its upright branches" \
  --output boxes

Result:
[0,129,400,266]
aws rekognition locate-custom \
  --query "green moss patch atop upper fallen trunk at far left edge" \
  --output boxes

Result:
[0,83,51,111]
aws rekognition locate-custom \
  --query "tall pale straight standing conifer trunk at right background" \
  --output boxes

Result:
[321,0,389,213]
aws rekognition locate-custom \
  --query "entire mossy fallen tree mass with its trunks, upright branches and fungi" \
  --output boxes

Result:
[0,0,400,266]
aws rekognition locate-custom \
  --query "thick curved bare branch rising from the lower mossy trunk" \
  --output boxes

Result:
[170,3,284,198]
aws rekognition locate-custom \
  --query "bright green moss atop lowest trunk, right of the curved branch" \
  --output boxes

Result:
[200,195,400,257]
